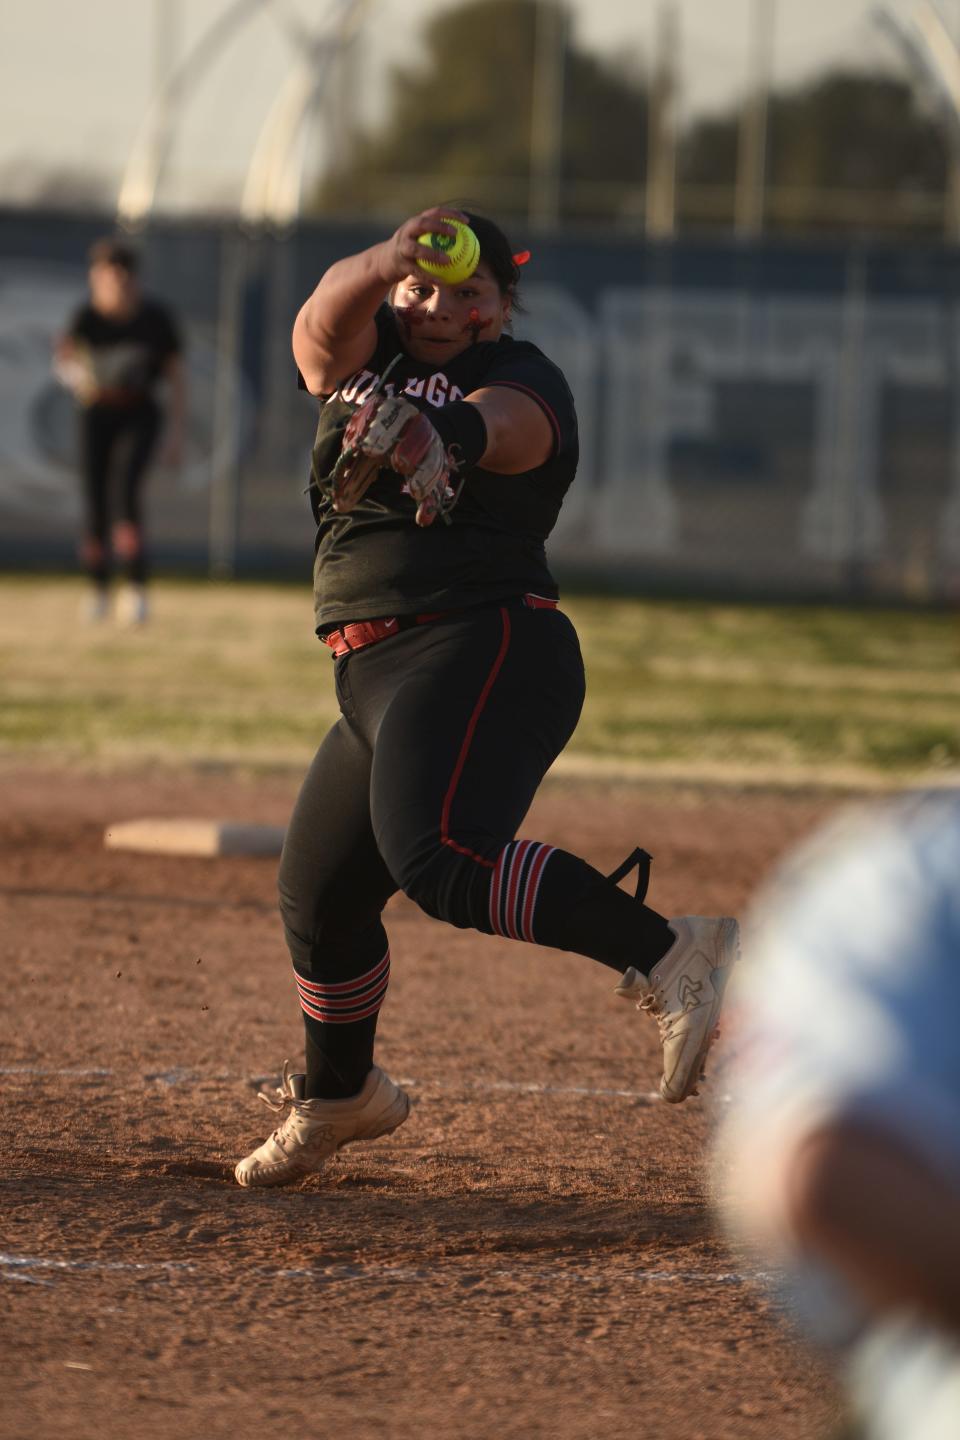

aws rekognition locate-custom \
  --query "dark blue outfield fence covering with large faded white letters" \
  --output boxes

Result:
[0,210,960,602]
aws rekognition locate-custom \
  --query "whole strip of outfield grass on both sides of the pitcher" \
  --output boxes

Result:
[0,577,960,785]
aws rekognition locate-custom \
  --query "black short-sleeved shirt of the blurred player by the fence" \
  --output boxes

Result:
[68,300,181,402]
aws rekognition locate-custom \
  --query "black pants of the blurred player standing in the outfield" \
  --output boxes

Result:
[79,399,161,585]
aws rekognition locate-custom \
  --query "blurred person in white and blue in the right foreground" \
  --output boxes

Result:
[718,792,960,1440]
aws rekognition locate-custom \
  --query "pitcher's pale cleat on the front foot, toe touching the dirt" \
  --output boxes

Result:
[233,1060,410,1187]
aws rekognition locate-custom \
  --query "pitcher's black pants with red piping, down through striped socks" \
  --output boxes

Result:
[273,600,674,1099]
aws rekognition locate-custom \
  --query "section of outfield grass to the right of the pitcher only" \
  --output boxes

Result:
[570,600,960,782]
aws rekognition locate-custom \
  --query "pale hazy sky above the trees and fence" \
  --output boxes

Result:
[0,0,960,212]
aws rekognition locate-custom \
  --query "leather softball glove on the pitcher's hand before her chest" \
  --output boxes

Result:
[328,393,456,526]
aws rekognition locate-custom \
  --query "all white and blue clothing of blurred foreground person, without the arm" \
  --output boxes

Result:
[717,791,960,1440]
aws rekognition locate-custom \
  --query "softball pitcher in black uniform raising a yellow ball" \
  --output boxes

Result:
[236,209,737,1185]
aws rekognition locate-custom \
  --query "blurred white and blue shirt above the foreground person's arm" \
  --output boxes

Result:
[727,792,960,1184]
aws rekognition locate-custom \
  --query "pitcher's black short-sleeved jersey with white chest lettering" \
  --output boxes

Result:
[311,305,579,629]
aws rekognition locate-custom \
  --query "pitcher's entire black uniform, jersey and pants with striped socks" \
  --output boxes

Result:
[279,307,674,1099]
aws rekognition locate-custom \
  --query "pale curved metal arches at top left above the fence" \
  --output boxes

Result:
[117,0,366,230]
